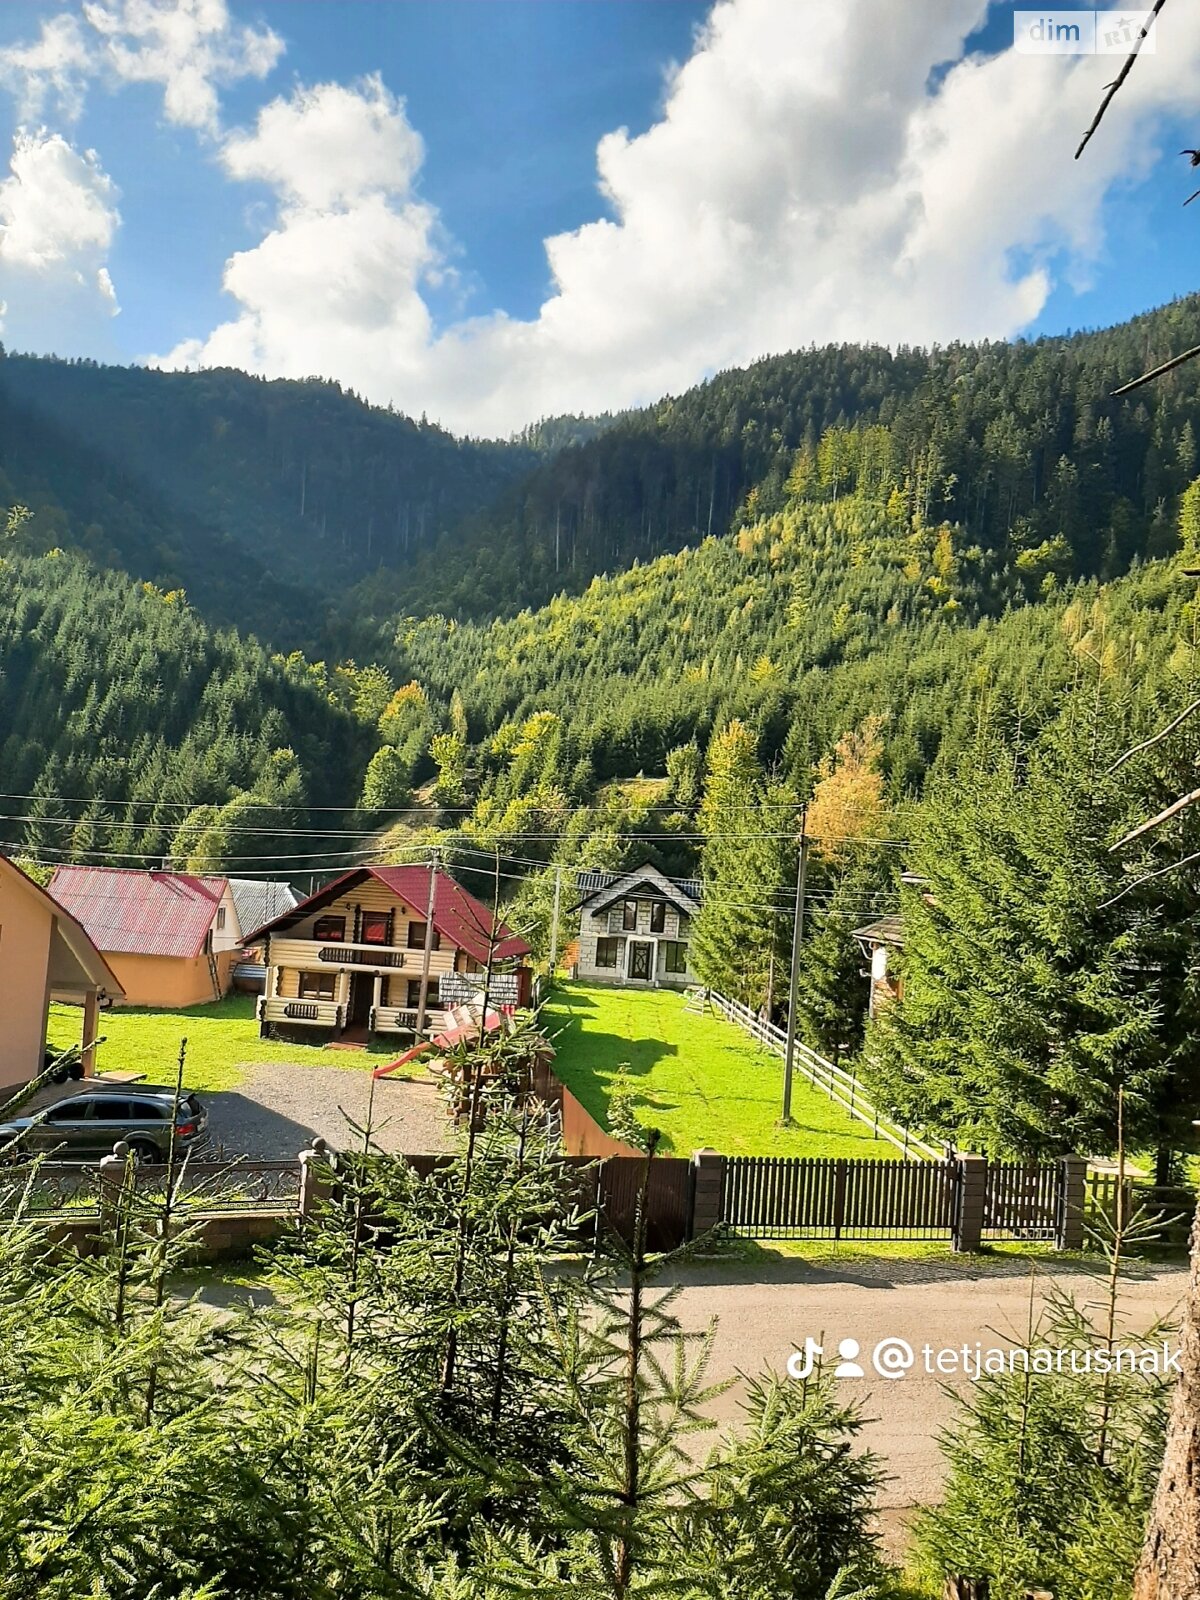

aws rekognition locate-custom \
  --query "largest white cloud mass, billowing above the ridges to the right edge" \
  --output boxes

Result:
[136,0,1200,432]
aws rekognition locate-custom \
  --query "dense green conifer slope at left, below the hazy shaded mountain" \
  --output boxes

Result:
[0,554,370,874]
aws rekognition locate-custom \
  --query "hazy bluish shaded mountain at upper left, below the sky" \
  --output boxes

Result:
[0,355,534,637]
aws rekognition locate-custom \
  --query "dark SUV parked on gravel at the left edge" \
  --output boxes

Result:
[0,1083,208,1166]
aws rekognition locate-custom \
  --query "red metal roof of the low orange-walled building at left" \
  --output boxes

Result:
[50,867,226,958]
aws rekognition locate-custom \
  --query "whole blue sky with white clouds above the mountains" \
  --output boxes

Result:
[0,0,1200,432]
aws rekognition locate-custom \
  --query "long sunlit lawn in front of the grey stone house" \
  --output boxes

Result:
[542,982,898,1157]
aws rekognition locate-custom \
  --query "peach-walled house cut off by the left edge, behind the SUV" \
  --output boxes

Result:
[0,856,123,1091]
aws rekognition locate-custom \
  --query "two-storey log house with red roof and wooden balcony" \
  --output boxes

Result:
[246,867,531,1043]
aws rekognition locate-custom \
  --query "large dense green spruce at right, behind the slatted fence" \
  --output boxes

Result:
[866,682,1200,1155]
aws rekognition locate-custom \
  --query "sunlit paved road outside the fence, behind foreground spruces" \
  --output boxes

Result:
[675,1256,1187,1550]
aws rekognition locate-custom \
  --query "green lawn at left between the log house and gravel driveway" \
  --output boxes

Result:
[50,995,406,1091]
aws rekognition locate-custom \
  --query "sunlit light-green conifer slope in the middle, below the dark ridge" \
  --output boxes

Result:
[394,480,1192,812]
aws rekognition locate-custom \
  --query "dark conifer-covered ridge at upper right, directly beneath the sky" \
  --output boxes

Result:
[355,296,1200,616]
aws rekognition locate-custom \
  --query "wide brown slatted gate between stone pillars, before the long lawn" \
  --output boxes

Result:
[722,1155,958,1238]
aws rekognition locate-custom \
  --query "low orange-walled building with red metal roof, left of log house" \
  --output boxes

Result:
[50,866,242,1010]
